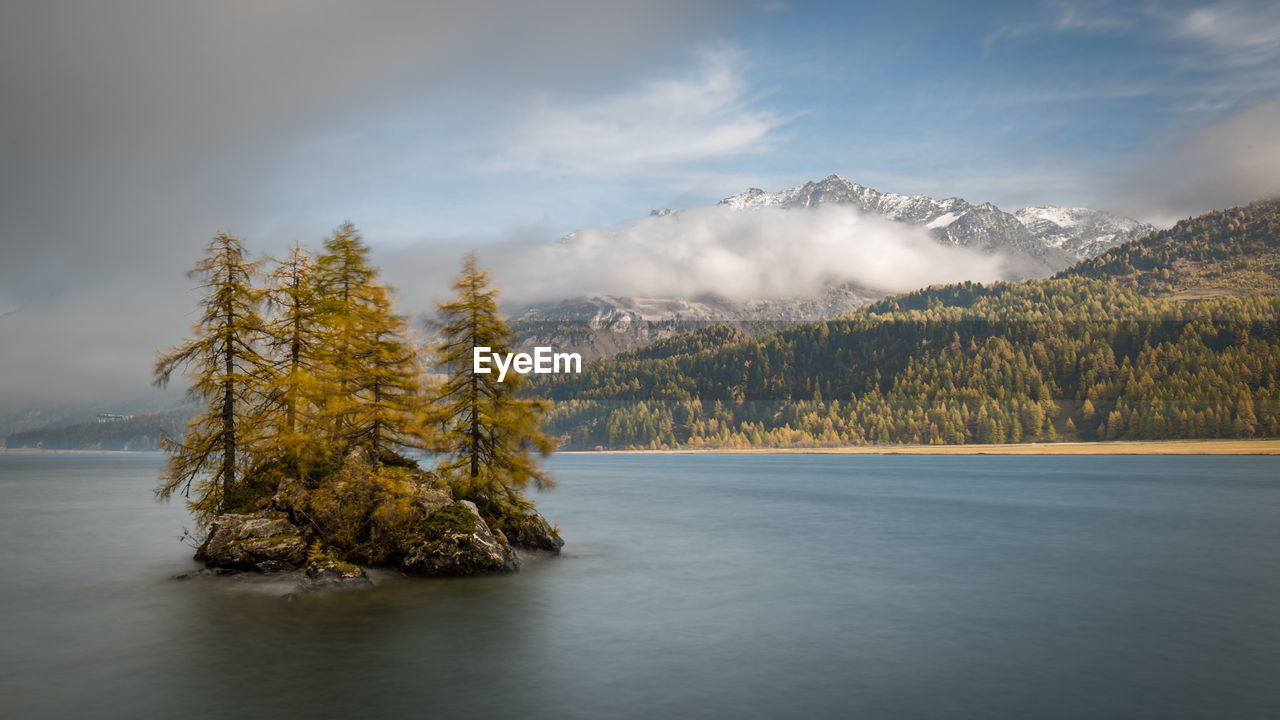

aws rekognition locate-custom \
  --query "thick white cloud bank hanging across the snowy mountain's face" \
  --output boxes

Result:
[388,205,1004,310]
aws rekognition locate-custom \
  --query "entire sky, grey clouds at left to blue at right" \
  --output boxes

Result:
[0,0,1280,410]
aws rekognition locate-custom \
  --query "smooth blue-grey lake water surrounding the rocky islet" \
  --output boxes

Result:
[0,455,1280,719]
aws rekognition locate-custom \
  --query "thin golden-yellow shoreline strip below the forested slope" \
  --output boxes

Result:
[562,439,1280,455]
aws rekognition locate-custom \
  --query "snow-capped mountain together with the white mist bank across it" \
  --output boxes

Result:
[512,174,1155,359]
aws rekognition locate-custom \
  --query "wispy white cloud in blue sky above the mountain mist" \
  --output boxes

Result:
[492,49,786,176]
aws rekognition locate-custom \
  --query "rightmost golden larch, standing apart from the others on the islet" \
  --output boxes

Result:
[436,255,556,507]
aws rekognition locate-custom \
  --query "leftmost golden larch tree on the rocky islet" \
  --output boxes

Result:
[155,233,266,523]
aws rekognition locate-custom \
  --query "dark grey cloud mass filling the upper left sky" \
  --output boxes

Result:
[0,0,723,414]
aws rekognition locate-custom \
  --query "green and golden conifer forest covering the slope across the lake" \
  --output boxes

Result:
[529,201,1280,450]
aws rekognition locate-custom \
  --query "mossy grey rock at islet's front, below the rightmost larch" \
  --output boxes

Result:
[402,500,520,575]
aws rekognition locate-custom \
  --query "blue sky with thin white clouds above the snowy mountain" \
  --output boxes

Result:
[249,3,1280,242]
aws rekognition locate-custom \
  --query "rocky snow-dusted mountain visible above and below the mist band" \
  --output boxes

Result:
[512,174,1155,360]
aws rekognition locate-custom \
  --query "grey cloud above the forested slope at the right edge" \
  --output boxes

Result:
[1098,101,1280,225]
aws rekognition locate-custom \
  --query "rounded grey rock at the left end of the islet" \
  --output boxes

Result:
[196,510,307,573]
